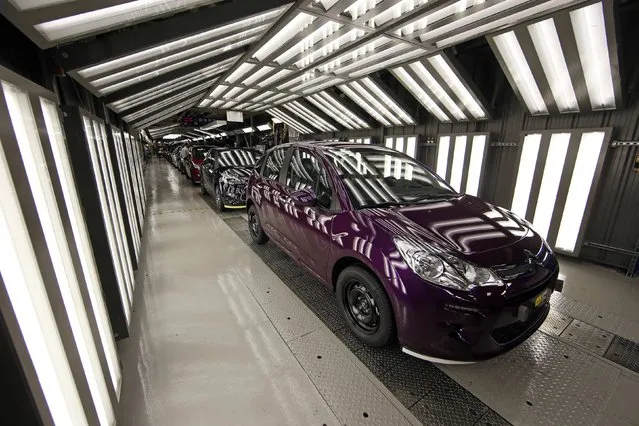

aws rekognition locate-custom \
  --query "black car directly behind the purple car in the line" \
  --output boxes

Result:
[201,148,262,211]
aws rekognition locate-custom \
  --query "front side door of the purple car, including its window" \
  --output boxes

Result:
[280,148,338,278]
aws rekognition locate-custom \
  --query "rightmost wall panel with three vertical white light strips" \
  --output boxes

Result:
[511,128,611,255]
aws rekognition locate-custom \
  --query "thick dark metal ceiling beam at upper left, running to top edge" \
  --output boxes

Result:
[48,0,290,70]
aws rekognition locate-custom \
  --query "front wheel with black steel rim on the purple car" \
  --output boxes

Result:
[335,266,396,348]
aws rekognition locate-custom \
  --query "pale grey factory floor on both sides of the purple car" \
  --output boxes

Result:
[118,160,639,426]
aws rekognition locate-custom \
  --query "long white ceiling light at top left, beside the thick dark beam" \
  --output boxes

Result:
[35,0,216,41]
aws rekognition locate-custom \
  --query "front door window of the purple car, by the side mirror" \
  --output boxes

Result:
[286,149,333,209]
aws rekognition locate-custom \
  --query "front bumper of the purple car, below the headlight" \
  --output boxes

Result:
[396,270,563,363]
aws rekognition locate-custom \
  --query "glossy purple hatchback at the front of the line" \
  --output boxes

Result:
[247,142,563,363]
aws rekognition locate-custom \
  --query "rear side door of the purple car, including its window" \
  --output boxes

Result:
[251,148,287,243]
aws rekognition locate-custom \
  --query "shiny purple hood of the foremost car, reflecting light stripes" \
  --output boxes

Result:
[368,195,532,256]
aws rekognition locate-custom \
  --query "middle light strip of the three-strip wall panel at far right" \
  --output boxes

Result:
[533,133,570,238]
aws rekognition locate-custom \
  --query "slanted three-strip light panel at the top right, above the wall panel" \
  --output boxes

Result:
[488,0,620,115]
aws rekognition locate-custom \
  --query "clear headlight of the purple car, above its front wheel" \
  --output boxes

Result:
[394,237,503,290]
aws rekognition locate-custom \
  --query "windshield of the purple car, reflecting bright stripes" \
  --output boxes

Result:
[326,147,457,208]
